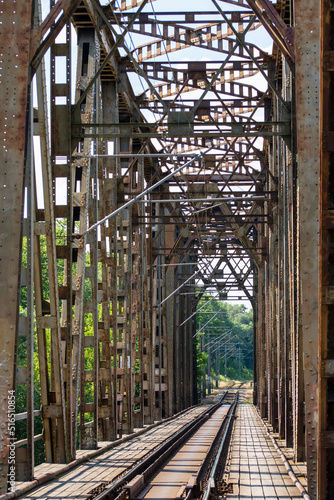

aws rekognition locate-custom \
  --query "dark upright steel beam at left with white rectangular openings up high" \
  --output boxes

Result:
[50,16,75,463]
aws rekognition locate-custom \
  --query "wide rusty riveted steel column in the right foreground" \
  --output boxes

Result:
[294,0,324,499]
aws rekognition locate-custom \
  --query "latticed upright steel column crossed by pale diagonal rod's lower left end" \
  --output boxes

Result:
[72,29,99,453]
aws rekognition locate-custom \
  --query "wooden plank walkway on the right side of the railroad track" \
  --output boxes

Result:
[226,404,302,500]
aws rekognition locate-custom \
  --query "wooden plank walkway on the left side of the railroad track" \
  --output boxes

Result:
[17,406,208,500]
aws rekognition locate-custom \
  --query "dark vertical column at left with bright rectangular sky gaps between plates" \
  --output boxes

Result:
[50,15,73,462]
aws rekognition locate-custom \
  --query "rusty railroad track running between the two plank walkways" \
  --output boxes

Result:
[89,391,238,500]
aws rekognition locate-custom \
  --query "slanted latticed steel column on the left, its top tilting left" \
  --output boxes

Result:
[34,49,66,462]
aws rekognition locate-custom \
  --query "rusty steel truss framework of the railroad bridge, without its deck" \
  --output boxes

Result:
[0,0,334,500]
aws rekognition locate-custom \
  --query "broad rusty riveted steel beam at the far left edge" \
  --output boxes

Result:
[0,0,32,493]
